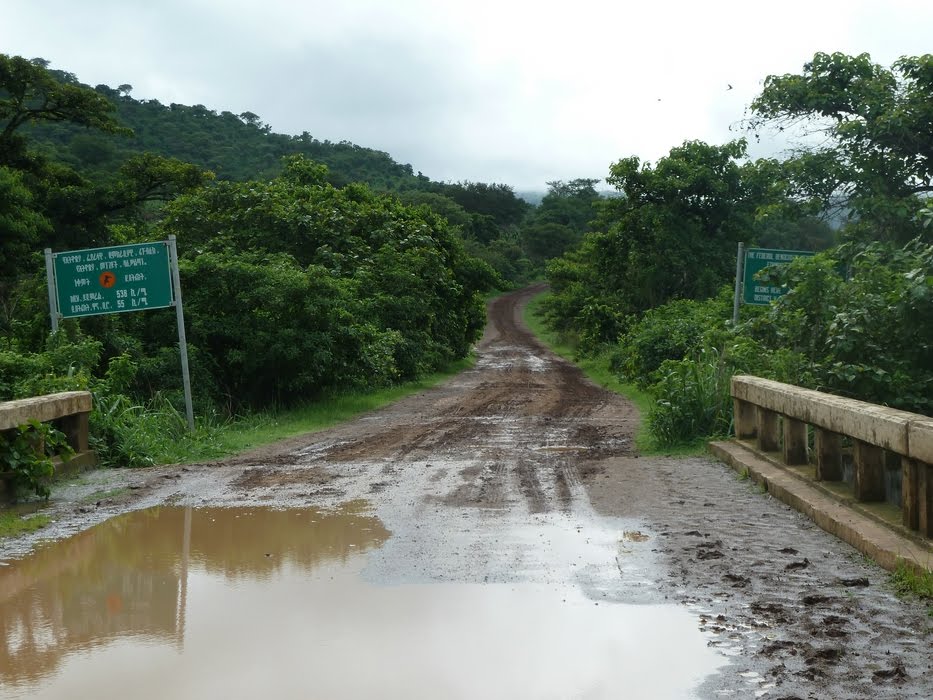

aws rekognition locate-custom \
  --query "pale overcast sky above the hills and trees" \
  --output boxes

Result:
[0,0,933,190]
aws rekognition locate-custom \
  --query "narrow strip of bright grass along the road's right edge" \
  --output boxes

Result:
[524,292,706,457]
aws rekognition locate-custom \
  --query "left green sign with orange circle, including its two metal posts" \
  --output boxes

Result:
[45,241,194,431]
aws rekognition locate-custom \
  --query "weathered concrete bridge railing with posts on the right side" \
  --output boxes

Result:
[732,375,933,537]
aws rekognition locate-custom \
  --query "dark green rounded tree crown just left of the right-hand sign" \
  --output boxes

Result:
[597,140,766,313]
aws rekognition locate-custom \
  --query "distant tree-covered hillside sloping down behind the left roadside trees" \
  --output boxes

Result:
[17,59,612,285]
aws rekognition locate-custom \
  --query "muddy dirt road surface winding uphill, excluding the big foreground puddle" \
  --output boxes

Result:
[0,290,933,700]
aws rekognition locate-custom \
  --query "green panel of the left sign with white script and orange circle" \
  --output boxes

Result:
[52,241,172,318]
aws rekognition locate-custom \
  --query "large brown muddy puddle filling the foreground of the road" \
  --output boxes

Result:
[0,502,724,700]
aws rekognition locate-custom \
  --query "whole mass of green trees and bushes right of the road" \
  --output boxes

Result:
[547,53,933,445]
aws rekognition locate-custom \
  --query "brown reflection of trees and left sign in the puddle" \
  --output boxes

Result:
[0,503,389,688]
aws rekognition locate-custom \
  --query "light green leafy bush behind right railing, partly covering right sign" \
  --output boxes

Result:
[748,240,933,415]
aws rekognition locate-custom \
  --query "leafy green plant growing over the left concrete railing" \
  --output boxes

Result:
[0,419,74,499]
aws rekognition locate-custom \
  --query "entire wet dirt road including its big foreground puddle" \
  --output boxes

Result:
[0,292,933,698]
